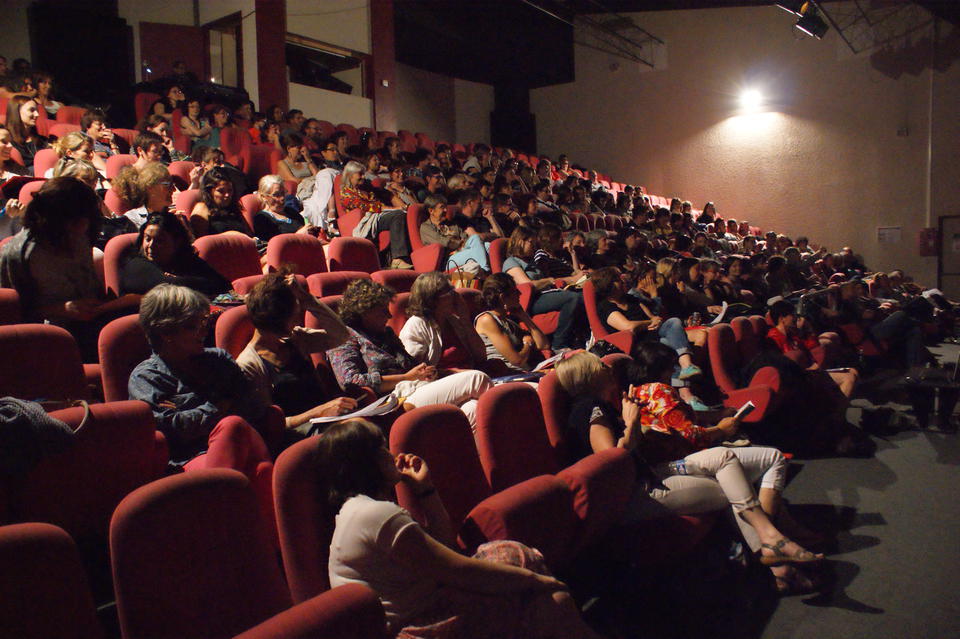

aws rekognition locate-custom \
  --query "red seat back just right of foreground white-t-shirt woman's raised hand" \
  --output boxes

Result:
[390,404,492,530]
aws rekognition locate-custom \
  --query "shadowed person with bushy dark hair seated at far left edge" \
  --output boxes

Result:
[0,177,140,362]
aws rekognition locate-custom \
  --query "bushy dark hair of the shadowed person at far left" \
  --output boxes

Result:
[23,177,103,250]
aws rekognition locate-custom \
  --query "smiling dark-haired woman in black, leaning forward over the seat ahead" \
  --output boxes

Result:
[120,211,231,298]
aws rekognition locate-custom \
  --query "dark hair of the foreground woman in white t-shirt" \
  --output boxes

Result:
[317,419,386,515]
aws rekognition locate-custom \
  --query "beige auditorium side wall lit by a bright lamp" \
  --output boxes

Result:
[531,7,960,283]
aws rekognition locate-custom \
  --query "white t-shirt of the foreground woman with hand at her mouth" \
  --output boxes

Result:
[328,495,437,628]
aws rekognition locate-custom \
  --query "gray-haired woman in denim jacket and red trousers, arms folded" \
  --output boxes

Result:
[127,284,270,477]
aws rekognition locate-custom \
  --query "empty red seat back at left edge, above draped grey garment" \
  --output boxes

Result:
[0,324,88,400]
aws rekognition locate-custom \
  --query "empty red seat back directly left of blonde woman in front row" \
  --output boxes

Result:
[476,383,560,492]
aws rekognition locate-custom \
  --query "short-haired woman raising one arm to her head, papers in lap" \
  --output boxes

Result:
[237,270,357,435]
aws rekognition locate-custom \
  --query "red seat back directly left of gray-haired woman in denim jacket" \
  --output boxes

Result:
[98,315,150,402]
